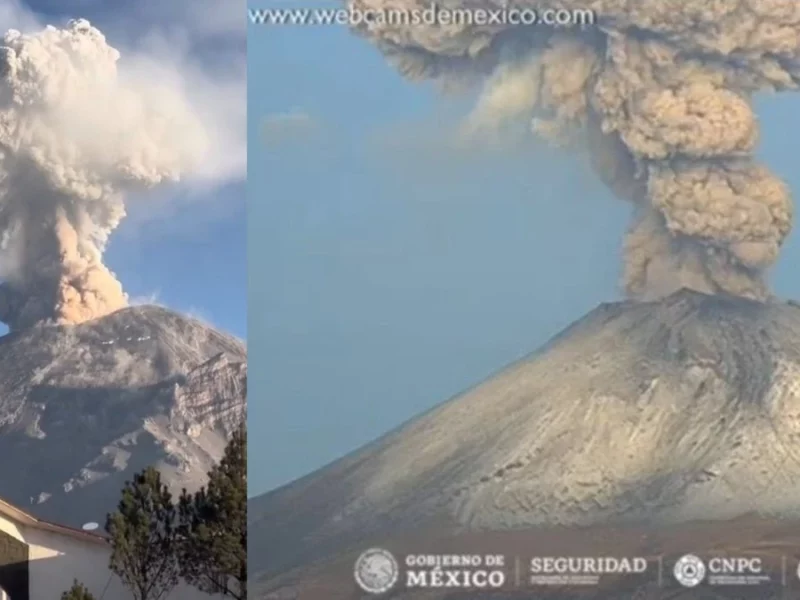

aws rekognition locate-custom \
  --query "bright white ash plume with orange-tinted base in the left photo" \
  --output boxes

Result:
[0,20,207,329]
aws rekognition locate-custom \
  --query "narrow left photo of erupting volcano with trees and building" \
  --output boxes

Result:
[0,0,247,600]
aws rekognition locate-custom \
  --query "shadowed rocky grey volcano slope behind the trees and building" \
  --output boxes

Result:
[0,306,247,526]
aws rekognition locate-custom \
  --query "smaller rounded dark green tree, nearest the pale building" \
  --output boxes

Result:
[106,467,179,600]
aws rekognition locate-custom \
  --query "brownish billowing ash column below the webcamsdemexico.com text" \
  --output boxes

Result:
[350,0,800,299]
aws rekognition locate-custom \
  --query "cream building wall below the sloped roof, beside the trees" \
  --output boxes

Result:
[23,528,222,600]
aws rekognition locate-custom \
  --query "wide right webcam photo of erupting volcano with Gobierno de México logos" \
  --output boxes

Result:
[250,0,800,600]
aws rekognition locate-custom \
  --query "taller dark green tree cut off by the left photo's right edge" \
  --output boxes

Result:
[178,425,247,600]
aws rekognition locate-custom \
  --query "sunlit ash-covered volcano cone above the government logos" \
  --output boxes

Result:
[249,290,800,576]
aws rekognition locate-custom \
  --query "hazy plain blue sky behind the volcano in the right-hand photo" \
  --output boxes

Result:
[253,2,800,495]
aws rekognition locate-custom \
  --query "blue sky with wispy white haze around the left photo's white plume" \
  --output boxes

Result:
[0,0,247,338]
